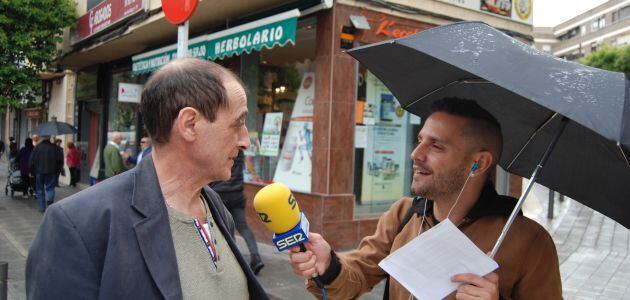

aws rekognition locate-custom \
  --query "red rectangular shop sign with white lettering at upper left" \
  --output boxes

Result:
[72,0,144,43]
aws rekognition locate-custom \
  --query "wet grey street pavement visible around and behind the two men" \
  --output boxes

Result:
[0,162,630,300]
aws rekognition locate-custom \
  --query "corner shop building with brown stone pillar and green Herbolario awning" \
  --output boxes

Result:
[53,0,533,248]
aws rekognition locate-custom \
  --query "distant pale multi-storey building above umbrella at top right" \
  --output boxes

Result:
[534,0,630,61]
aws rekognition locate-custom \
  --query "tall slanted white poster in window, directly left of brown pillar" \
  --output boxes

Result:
[273,72,315,192]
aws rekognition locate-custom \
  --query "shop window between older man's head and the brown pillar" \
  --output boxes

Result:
[240,18,316,192]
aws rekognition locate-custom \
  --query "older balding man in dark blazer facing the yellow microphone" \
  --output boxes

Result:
[26,59,267,299]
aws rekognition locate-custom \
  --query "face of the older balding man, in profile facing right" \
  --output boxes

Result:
[193,79,250,181]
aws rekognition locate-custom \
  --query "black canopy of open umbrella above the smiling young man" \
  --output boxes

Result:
[349,22,630,228]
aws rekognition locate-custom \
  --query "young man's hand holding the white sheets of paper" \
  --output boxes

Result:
[452,272,499,300]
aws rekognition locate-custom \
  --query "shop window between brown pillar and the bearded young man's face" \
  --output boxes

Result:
[354,67,420,215]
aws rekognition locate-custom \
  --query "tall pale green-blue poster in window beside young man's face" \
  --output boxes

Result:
[361,72,409,204]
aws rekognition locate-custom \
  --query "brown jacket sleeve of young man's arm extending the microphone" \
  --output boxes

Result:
[307,198,412,300]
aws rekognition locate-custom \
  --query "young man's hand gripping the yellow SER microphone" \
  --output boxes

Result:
[289,232,331,278]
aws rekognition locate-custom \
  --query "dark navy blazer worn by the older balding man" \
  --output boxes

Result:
[26,156,268,300]
